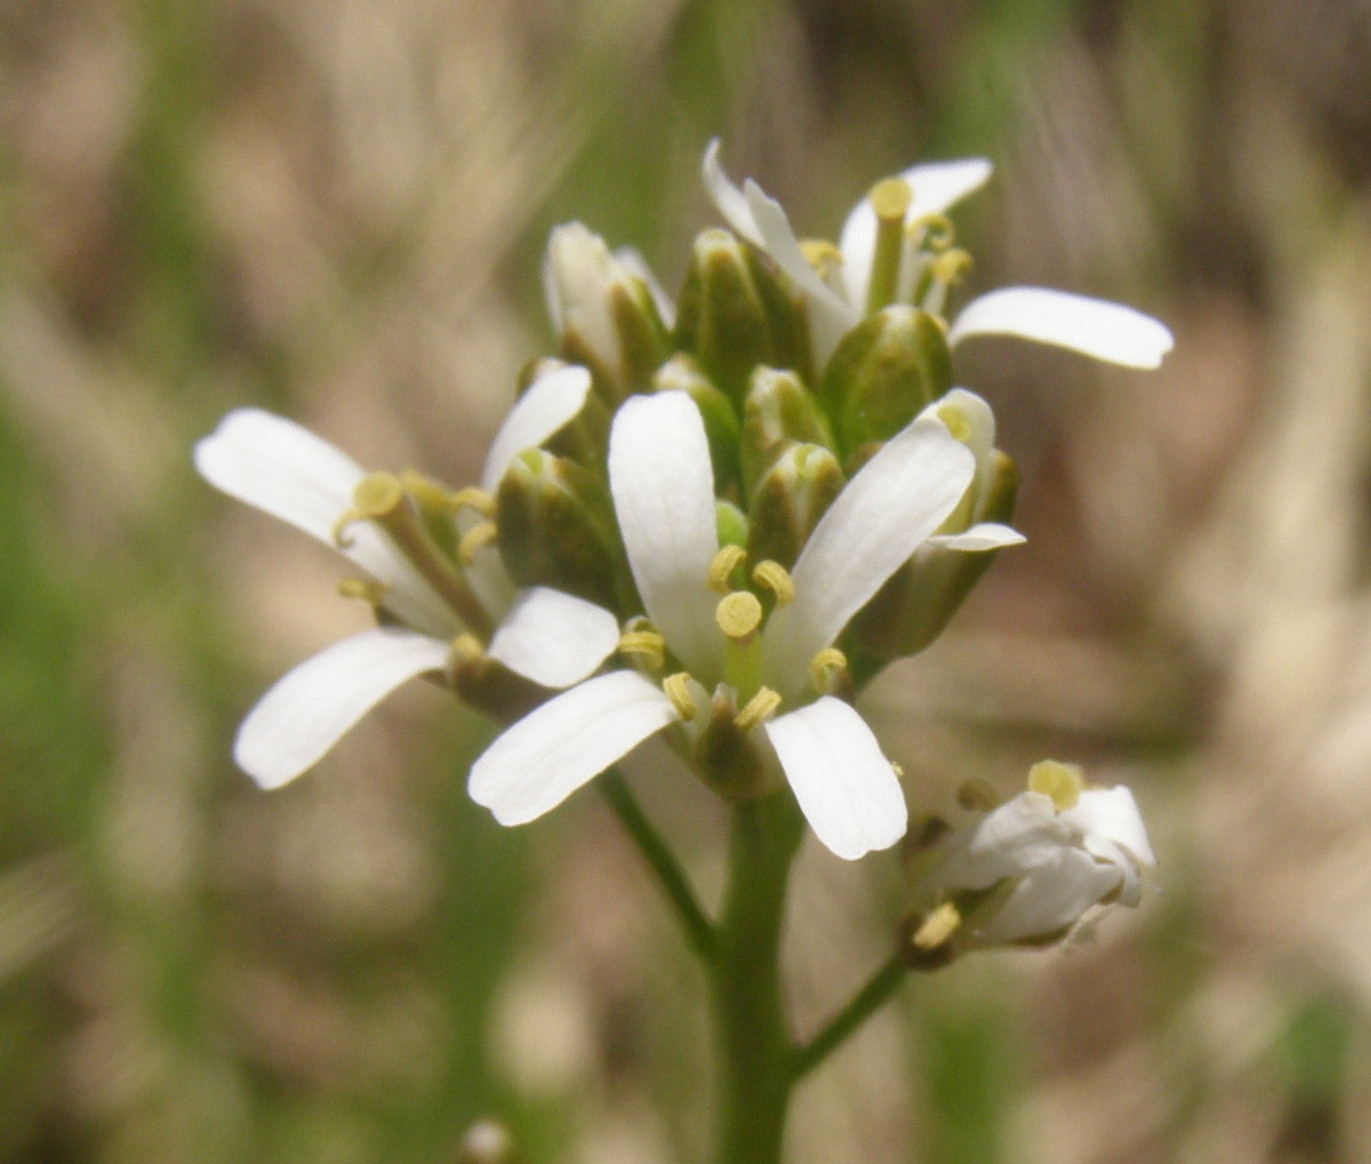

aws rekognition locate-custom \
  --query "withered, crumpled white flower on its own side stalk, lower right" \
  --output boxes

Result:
[920,761,1156,946]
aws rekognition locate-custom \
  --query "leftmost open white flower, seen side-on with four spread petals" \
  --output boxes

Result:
[195,367,618,788]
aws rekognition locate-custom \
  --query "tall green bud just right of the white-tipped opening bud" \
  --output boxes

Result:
[676,230,809,406]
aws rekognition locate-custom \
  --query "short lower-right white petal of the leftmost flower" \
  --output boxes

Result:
[488,587,618,687]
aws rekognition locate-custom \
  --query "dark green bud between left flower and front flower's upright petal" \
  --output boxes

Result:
[495,448,633,614]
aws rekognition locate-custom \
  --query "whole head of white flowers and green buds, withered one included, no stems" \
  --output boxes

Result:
[196,143,1171,946]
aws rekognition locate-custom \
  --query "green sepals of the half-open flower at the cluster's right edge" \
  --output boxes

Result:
[847,448,1019,686]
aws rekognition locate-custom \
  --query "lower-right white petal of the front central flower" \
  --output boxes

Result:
[766,695,909,861]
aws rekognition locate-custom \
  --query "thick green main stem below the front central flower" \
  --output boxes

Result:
[712,794,803,1164]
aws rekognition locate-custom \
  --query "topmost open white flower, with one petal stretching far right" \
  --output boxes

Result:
[703,138,1172,367]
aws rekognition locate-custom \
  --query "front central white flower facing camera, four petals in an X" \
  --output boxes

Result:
[469,391,975,860]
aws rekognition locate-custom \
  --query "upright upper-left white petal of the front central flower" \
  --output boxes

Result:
[609,391,723,686]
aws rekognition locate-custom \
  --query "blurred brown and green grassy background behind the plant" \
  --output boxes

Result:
[0,0,1371,1164]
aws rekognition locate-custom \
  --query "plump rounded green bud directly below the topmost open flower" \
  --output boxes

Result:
[818,306,951,461]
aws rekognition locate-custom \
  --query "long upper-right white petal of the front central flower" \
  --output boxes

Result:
[764,420,975,695]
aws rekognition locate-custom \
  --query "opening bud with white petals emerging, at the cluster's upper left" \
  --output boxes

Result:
[543,222,668,406]
